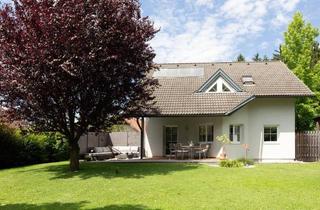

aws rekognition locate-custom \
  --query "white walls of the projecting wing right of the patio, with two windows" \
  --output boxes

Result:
[223,98,295,162]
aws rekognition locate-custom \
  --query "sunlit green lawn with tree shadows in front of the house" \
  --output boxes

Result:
[0,162,320,210]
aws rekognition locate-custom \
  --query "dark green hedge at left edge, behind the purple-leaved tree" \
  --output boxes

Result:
[0,125,68,168]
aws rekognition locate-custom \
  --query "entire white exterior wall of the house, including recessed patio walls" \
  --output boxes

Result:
[145,98,295,161]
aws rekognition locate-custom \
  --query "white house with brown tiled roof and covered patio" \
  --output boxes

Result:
[142,61,313,162]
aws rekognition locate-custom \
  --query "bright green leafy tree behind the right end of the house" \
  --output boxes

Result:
[279,12,320,130]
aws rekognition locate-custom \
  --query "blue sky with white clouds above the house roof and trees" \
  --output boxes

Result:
[141,0,320,63]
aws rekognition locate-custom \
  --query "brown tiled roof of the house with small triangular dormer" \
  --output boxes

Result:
[150,62,313,116]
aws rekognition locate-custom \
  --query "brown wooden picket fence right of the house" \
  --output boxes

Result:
[296,131,320,162]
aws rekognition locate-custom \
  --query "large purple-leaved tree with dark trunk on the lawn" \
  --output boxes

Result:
[0,0,157,170]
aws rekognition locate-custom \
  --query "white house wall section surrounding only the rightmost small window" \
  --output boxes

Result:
[249,99,295,161]
